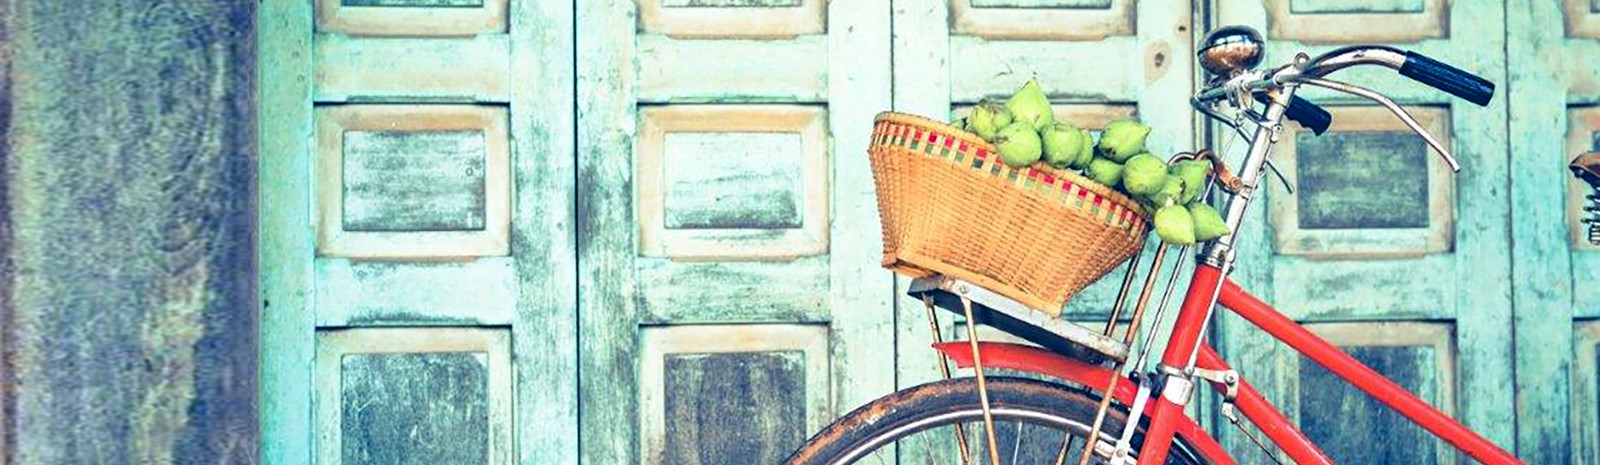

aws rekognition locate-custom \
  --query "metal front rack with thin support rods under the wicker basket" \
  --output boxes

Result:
[907,150,1232,465]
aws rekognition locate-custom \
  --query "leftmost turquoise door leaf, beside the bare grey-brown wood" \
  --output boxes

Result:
[259,0,578,465]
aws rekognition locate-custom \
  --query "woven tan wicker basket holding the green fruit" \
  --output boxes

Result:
[867,112,1149,316]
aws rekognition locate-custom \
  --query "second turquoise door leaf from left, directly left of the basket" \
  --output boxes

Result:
[578,0,893,463]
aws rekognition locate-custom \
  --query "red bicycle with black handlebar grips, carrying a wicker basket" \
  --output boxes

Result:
[786,27,1523,465]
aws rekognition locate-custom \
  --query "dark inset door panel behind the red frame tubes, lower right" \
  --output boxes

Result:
[1298,345,1448,463]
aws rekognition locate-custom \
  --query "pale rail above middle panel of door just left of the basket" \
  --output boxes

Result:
[637,35,829,102]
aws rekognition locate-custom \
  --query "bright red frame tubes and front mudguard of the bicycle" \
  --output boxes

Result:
[934,264,1522,463]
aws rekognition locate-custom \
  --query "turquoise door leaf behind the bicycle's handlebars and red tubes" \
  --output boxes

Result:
[1213,0,1515,463]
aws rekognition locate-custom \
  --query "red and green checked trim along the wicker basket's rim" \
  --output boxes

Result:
[872,121,1144,232]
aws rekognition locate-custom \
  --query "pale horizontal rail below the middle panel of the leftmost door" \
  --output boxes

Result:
[315,257,520,328]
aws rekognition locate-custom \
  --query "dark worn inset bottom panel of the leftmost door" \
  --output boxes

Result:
[339,353,490,465]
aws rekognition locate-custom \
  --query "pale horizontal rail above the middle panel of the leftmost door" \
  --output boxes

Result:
[312,34,510,102]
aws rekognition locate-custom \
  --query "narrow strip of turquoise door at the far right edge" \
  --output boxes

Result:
[1507,2,1600,463]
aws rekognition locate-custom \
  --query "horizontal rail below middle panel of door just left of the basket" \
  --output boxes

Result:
[637,257,832,324]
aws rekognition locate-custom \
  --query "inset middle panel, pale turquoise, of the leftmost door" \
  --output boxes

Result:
[344,131,486,232]
